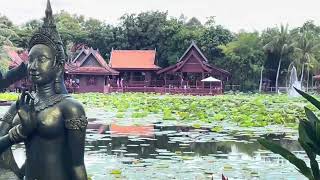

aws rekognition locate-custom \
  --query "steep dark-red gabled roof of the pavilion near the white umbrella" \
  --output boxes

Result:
[157,41,230,76]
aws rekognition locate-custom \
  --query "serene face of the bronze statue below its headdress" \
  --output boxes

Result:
[28,44,56,85]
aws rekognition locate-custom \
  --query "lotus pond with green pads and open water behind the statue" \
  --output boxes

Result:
[0,93,317,180]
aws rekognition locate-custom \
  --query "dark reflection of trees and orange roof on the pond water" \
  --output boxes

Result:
[87,124,303,158]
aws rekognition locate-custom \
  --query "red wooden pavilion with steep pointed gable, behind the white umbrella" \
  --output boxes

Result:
[157,42,230,92]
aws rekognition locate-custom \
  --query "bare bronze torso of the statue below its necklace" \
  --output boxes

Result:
[14,98,85,180]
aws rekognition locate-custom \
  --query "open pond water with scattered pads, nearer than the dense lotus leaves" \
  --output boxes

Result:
[0,106,306,180]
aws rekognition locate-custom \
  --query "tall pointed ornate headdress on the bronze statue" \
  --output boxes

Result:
[29,0,65,64]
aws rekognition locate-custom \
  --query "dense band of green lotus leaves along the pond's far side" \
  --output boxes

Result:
[0,93,315,128]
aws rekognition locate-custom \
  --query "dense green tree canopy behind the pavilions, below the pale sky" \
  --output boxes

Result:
[0,11,320,90]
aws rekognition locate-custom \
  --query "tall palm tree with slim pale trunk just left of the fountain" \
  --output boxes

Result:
[263,25,293,92]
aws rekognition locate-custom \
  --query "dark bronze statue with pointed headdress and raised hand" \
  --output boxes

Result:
[0,0,87,180]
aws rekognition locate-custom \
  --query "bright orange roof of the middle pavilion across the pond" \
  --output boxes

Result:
[109,50,160,70]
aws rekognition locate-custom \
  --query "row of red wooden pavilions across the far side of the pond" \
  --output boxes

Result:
[3,42,230,95]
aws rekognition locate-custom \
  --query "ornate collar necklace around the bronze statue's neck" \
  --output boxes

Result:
[34,94,70,112]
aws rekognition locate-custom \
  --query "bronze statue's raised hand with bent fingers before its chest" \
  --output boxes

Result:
[17,91,37,136]
